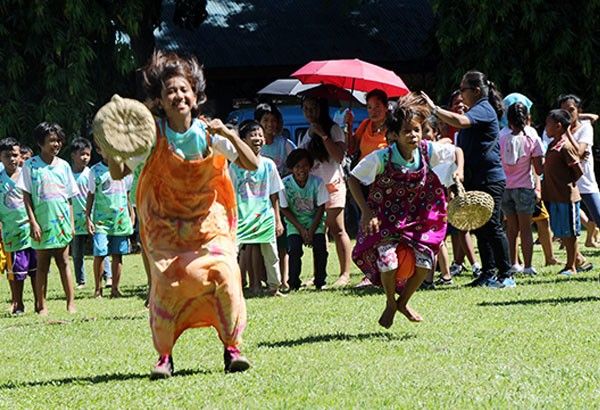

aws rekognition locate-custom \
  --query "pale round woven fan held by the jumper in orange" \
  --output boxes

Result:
[92,94,156,159]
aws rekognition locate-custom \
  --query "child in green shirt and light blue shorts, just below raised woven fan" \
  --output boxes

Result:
[85,147,133,298]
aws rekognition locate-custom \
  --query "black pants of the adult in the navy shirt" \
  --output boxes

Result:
[469,181,511,278]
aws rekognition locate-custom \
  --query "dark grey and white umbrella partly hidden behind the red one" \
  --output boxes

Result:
[257,78,367,105]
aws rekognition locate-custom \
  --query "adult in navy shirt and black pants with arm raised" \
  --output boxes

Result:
[424,71,515,288]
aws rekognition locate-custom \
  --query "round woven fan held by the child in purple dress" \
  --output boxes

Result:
[448,180,494,231]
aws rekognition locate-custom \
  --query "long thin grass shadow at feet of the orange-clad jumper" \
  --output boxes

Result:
[0,369,214,390]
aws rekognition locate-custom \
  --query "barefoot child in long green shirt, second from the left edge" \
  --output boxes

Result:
[17,122,77,316]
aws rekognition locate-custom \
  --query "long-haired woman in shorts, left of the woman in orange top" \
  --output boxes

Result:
[298,96,352,286]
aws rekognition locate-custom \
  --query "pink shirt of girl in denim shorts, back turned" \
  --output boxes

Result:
[500,127,544,189]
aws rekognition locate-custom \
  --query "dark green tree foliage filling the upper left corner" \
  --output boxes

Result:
[0,0,160,147]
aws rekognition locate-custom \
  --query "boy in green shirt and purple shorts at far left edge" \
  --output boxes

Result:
[0,138,37,315]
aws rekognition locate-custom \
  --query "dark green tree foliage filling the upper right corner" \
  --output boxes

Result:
[433,0,600,121]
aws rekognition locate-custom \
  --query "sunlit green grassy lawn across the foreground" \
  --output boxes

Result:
[0,237,600,408]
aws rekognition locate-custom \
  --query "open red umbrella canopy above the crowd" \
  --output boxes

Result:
[292,58,410,97]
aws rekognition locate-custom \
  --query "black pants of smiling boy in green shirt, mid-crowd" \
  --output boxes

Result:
[288,233,328,289]
